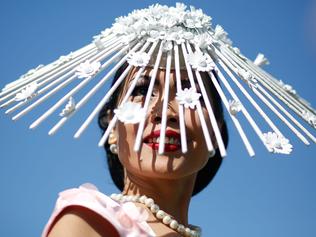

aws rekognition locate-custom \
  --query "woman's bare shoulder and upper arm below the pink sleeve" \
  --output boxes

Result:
[48,206,119,237]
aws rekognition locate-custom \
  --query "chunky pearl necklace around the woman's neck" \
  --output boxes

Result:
[110,193,202,237]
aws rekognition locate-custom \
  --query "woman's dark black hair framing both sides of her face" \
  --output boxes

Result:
[98,63,228,196]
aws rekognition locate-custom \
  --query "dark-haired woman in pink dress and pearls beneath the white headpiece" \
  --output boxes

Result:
[43,61,228,237]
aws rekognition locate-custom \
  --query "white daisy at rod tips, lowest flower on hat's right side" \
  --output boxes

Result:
[263,132,293,155]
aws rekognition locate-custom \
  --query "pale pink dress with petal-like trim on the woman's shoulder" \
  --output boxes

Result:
[42,183,155,237]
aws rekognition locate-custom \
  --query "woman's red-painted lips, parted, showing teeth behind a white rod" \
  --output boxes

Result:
[144,130,181,152]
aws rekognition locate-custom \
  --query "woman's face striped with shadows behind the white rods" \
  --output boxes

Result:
[110,68,216,179]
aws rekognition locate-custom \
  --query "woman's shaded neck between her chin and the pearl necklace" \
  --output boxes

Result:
[123,172,196,225]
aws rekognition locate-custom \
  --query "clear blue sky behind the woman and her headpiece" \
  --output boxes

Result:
[0,0,316,237]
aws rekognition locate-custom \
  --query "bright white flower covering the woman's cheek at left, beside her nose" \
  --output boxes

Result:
[114,102,146,124]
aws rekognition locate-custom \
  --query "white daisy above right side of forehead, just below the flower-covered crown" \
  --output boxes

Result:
[188,51,215,72]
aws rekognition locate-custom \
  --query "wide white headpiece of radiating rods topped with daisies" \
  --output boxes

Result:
[0,3,316,157]
